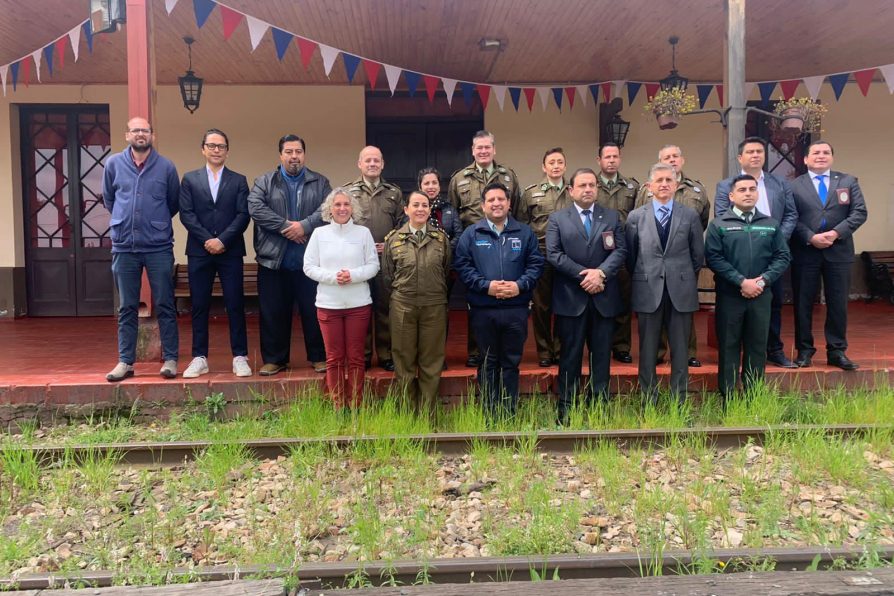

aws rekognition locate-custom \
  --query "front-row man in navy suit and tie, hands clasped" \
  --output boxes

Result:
[546,168,627,424]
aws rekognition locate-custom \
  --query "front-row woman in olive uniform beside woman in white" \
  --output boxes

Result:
[382,191,451,414]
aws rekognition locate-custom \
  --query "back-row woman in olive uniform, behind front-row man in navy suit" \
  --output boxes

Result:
[515,147,571,367]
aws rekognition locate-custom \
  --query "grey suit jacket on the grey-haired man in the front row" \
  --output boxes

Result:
[626,201,705,313]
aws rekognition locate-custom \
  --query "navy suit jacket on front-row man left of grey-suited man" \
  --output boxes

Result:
[546,203,627,318]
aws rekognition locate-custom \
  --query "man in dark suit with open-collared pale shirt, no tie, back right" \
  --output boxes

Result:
[714,137,798,368]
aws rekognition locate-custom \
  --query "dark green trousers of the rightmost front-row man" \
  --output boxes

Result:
[716,290,773,397]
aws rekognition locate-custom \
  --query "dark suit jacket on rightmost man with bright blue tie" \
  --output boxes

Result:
[791,171,867,263]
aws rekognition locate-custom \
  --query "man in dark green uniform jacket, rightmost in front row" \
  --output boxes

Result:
[705,174,791,398]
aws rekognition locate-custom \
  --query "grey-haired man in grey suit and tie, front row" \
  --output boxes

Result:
[626,163,705,401]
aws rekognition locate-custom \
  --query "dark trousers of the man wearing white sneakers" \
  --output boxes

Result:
[187,253,248,358]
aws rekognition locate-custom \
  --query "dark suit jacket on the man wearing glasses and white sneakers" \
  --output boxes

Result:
[180,167,249,257]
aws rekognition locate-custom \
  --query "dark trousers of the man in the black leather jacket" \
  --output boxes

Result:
[258,265,326,364]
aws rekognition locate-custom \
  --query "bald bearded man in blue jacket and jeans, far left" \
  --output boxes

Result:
[102,117,180,382]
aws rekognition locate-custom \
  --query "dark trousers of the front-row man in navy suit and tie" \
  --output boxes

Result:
[556,300,616,419]
